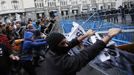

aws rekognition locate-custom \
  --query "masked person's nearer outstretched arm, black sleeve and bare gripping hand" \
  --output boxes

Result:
[63,28,121,72]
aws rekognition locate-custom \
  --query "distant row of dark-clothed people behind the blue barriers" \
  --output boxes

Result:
[71,4,134,24]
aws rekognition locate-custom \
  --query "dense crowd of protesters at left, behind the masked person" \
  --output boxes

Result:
[0,17,55,75]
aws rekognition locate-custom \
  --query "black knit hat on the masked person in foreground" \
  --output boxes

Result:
[46,32,65,49]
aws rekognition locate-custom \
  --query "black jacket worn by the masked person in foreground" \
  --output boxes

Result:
[45,40,106,75]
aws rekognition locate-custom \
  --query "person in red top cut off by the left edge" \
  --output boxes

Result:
[0,27,11,75]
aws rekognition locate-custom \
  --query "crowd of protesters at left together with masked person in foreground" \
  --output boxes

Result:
[0,4,123,75]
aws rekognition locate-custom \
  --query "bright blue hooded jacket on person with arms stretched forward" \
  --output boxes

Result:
[21,32,47,61]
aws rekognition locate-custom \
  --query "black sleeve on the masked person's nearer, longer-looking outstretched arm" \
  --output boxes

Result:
[63,40,106,73]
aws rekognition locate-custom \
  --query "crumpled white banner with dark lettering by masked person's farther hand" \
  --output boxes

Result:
[64,22,101,43]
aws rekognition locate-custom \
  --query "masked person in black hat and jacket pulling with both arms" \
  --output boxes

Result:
[45,28,121,75]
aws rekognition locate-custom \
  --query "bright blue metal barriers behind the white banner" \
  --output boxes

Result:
[60,12,134,45]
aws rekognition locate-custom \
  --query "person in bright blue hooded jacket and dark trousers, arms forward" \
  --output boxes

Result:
[20,32,46,75]
